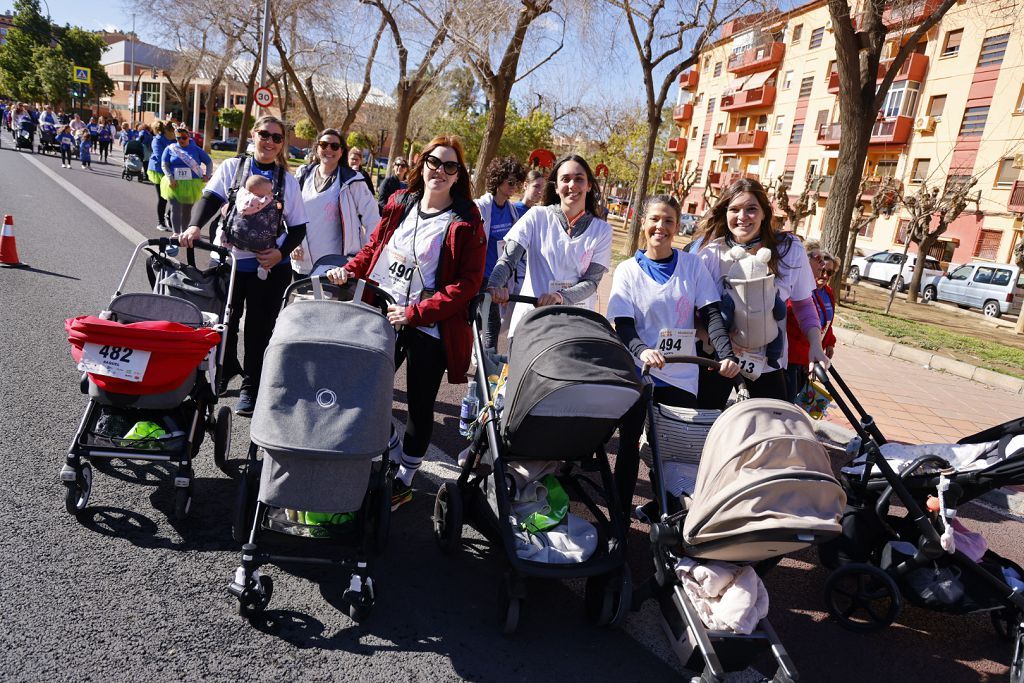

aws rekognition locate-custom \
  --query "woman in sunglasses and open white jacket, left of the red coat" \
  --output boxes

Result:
[292,128,381,276]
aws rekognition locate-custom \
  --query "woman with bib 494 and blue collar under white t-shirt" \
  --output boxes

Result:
[607,195,739,515]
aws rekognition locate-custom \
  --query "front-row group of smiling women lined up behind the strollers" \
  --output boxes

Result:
[176,117,827,518]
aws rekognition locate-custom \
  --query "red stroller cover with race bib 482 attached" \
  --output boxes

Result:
[65,315,220,395]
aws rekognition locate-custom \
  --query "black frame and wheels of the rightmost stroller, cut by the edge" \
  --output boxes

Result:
[815,366,1024,683]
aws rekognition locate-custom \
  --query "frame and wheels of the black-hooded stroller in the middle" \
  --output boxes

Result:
[432,294,633,635]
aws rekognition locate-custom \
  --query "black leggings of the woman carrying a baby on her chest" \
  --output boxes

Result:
[224,262,292,394]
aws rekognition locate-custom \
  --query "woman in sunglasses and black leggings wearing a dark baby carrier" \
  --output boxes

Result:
[178,116,306,417]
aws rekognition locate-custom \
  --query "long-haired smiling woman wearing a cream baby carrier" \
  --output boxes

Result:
[698,178,828,409]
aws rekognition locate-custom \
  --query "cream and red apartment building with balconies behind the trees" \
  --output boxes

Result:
[662,0,1024,263]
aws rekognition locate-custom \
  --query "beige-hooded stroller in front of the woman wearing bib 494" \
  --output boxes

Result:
[647,357,846,683]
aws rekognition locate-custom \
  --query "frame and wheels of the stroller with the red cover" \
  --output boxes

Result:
[60,238,236,520]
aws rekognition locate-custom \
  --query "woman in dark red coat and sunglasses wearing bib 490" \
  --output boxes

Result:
[328,135,487,509]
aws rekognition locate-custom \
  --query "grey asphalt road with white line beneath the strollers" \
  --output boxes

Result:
[0,138,1024,682]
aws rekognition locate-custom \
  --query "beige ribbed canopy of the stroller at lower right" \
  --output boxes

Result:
[683,398,846,561]
